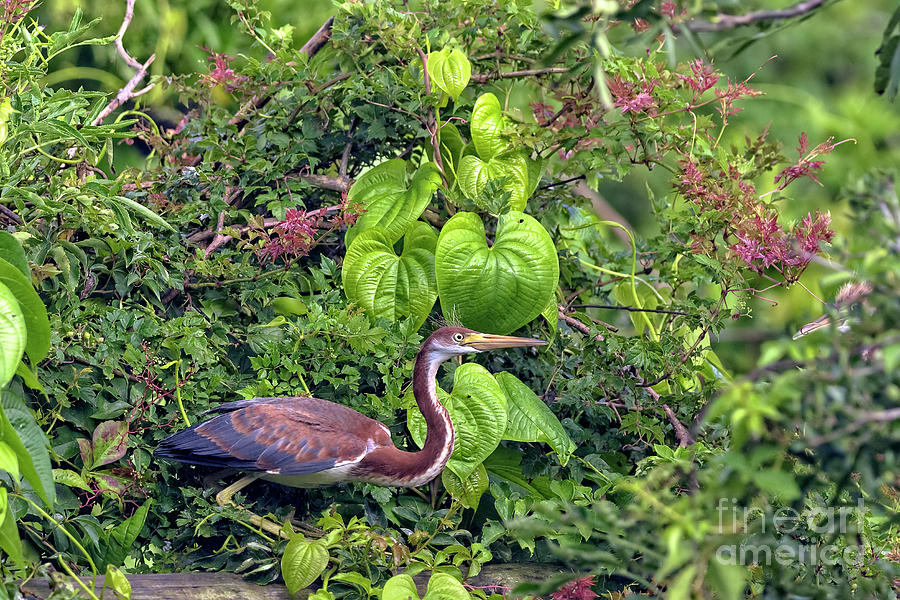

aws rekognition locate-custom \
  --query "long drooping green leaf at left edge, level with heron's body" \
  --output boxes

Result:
[0,389,56,507]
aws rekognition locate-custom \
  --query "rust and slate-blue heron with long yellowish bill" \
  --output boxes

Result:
[154,327,547,533]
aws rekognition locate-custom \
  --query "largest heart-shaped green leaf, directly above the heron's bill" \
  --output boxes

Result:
[435,212,559,334]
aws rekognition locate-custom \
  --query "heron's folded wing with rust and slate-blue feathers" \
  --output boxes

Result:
[156,398,390,475]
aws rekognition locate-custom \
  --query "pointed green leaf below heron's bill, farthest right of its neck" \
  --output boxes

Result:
[494,371,575,466]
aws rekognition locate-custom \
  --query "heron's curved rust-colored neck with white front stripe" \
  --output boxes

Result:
[359,342,454,487]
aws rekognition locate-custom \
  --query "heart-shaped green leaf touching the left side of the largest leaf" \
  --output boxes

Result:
[341,221,437,329]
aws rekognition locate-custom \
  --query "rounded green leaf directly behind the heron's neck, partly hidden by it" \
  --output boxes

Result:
[406,363,506,481]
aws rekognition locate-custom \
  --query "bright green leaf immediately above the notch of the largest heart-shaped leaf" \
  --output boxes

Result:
[457,150,537,210]
